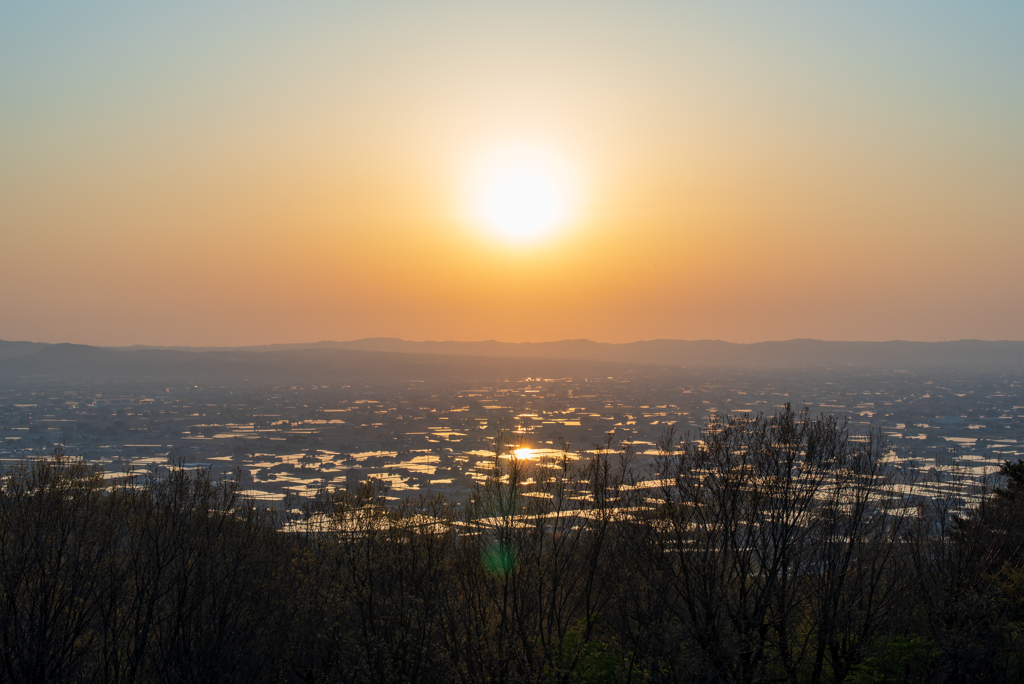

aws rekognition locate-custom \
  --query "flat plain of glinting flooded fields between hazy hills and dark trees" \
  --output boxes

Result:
[0,369,1024,502]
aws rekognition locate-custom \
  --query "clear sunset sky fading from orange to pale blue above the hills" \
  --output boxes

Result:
[0,0,1024,346]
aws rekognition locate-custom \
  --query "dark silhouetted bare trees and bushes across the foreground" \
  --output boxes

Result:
[0,407,1024,684]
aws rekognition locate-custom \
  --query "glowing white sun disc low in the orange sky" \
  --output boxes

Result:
[470,147,575,244]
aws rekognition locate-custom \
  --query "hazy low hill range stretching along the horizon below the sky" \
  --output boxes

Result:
[0,338,1024,382]
